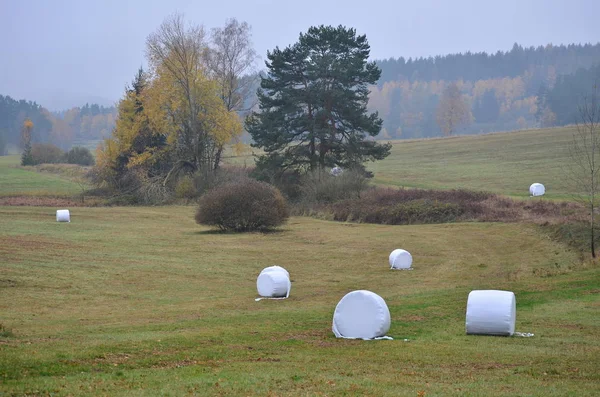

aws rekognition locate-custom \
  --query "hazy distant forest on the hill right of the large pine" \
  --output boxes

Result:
[369,44,600,139]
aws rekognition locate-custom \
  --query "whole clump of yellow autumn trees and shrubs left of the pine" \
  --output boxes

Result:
[95,14,242,198]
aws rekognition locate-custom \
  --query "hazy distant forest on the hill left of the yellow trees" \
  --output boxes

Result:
[0,95,116,155]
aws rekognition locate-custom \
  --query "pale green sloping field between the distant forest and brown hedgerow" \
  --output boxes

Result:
[369,127,574,198]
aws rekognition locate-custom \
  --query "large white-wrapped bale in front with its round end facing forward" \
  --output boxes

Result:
[332,290,392,339]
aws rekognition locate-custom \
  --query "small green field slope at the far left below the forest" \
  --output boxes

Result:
[0,155,81,196]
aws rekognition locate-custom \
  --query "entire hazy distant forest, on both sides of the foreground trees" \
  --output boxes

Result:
[0,43,600,155]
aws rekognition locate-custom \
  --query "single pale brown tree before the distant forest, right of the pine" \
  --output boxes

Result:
[436,83,473,135]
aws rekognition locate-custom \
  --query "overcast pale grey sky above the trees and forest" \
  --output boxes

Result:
[0,0,600,110]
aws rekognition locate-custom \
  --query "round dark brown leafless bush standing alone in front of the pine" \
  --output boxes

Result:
[196,179,289,232]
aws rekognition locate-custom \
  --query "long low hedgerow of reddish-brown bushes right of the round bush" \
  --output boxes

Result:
[296,188,585,225]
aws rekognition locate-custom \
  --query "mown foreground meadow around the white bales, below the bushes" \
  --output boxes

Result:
[0,207,600,396]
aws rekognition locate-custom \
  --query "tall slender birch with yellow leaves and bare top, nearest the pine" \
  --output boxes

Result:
[146,14,242,183]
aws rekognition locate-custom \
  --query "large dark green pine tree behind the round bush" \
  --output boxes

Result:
[246,26,391,171]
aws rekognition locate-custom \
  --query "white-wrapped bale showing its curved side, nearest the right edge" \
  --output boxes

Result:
[466,290,517,336]
